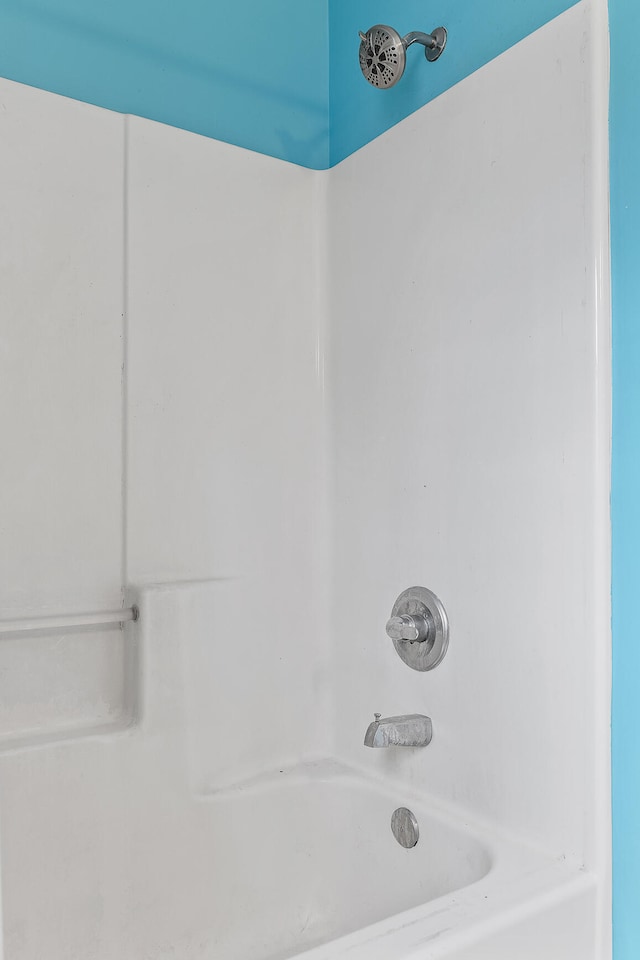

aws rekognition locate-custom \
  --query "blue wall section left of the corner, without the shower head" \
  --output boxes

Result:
[0,0,329,168]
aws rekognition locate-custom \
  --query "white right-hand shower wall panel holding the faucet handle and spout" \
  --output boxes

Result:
[328,4,610,908]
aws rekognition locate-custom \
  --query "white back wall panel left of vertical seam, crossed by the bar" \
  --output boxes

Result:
[0,80,126,746]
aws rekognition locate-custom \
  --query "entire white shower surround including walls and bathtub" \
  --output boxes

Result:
[0,0,610,960]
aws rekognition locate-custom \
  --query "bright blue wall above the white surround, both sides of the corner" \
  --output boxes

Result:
[0,0,576,169]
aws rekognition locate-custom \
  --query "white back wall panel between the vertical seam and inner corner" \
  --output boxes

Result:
[127,118,330,785]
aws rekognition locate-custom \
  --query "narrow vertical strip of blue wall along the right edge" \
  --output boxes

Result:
[609,0,640,960]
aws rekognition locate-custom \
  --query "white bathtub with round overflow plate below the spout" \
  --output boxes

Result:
[3,752,595,960]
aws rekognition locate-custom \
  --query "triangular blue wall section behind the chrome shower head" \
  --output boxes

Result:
[329,0,577,165]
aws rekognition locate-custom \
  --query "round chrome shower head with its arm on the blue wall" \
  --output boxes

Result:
[359,23,447,90]
